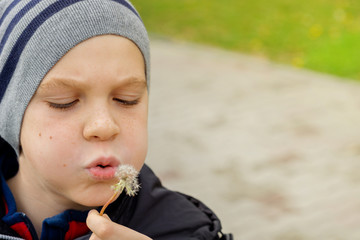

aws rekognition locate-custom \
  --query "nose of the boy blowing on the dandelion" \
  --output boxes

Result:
[83,108,120,141]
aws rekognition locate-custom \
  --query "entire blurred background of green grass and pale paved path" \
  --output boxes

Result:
[132,0,360,240]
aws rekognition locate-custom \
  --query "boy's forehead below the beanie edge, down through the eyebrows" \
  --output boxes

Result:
[39,35,147,89]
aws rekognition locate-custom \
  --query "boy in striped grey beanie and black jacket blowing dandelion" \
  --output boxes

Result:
[0,0,230,239]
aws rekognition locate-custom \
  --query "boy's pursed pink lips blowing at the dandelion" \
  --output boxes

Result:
[86,157,120,181]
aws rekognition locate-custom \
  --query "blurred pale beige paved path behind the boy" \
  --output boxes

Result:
[148,39,360,240]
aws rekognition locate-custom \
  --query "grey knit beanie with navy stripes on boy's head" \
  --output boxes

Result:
[0,0,150,155]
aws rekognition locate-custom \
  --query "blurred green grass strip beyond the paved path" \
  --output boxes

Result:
[132,0,360,80]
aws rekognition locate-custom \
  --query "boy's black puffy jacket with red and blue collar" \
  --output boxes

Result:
[0,140,232,240]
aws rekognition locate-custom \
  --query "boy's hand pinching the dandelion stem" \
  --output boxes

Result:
[86,210,151,240]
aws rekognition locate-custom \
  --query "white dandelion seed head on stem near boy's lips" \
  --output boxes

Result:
[100,165,140,216]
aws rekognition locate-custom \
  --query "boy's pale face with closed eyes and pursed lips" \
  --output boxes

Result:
[18,35,148,209]
